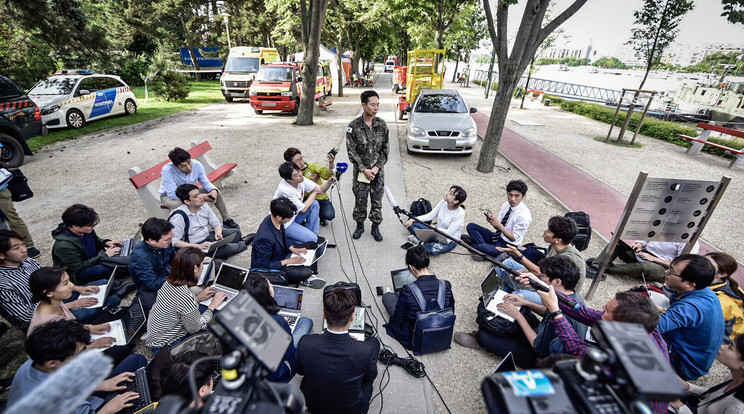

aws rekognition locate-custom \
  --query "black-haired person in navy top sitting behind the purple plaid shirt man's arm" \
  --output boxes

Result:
[455,255,587,368]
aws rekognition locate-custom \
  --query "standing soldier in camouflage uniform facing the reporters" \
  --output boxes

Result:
[346,90,390,242]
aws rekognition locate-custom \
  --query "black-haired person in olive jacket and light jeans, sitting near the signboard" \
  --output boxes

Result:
[496,216,586,304]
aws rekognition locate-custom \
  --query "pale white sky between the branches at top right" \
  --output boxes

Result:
[491,0,744,55]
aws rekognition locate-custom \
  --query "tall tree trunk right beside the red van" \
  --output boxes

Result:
[296,0,329,125]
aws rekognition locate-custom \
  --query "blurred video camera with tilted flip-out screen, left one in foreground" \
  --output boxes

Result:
[156,291,305,414]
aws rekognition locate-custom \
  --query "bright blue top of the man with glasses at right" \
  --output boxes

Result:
[658,287,724,380]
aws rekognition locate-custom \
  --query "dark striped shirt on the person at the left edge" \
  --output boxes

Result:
[0,258,41,332]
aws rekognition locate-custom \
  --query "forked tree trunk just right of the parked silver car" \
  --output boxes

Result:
[476,0,587,173]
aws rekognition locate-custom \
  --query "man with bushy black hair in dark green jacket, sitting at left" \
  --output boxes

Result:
[52,204,122,285]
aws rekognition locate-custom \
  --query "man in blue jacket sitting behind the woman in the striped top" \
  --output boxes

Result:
[129,217,176,314]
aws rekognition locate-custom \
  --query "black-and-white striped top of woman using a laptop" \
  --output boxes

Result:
[145,280,212,348]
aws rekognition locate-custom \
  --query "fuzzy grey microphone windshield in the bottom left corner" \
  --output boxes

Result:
[5,351,114,414]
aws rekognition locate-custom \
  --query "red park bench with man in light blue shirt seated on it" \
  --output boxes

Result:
[129,141,238,219]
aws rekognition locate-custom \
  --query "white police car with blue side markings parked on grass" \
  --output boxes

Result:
[28,70,137,128]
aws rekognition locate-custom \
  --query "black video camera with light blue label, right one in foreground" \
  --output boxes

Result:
[481,321,686,414]
